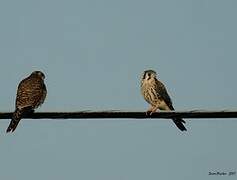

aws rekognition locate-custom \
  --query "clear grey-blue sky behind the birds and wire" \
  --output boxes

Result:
[0,0,237,180]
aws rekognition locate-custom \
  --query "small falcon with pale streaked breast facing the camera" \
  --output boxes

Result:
[141,70,187,131]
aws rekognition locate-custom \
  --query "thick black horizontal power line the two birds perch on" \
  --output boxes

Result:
[0,110,237,120]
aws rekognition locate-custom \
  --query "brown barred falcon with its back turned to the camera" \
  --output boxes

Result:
[6,71,47,133]
